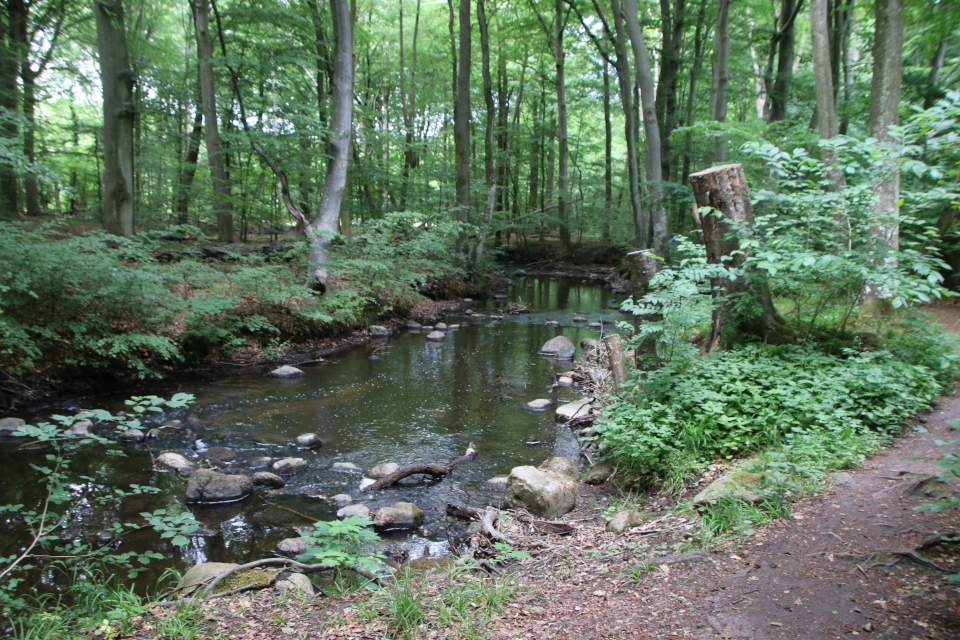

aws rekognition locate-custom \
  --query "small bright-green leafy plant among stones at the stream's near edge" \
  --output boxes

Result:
[297,516,380,569]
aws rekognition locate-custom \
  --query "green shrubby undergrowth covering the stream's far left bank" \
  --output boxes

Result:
[0,213,467,377]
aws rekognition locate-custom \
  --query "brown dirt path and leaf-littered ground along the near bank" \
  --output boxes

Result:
[122,306,960,640]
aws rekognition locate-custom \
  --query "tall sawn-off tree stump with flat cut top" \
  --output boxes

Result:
[690,164,782,353]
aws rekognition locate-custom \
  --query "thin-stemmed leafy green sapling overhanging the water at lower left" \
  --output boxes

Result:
[0,393,200,611]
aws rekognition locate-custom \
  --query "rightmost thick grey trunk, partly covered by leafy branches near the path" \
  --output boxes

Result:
[870,0,903,264]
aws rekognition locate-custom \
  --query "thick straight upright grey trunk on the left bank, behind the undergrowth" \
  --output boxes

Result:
[94,0,134,238]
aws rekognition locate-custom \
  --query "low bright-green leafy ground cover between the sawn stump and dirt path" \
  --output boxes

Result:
[596,345,940,475]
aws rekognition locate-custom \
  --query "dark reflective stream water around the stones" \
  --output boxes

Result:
[0,276,626,582]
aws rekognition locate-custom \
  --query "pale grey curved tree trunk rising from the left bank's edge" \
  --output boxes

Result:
[306,0,353,291]
